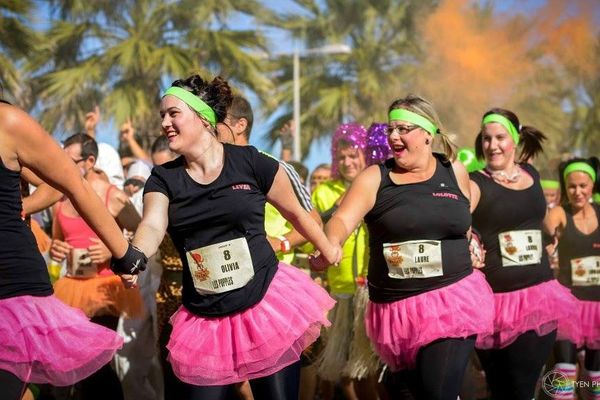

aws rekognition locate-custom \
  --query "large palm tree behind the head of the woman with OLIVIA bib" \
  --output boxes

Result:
[31,0,268,144]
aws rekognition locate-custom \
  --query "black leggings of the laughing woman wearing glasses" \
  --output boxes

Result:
[384,336,475,400]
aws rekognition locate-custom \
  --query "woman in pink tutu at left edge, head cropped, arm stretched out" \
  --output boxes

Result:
[0,93,146,400]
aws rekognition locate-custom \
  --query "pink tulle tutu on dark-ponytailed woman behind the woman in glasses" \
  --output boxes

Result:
[475,279,577,349]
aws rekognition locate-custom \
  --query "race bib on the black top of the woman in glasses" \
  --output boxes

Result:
[383,240,444,279]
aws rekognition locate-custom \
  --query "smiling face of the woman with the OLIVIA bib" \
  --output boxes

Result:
[160,96,208,154]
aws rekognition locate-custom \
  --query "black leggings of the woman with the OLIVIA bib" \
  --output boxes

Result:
[185,361,300,400]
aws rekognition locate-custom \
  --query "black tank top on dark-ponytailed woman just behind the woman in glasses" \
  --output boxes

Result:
[470,164,553,293]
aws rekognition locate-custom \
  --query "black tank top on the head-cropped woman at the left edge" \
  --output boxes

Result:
[0,155,52,299]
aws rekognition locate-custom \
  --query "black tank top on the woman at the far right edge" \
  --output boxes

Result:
[558,204,600,301]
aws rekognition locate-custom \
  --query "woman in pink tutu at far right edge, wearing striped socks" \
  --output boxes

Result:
[545,157,600,399]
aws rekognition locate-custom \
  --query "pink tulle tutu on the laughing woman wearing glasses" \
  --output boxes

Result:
[366,270,494,371]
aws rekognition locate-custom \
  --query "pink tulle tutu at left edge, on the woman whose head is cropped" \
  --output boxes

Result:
[0,296,123,386]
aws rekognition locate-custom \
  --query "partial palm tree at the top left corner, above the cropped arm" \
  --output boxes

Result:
[0,0,36,104]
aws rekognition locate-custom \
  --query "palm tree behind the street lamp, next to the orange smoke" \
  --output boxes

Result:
[263,0,434,156]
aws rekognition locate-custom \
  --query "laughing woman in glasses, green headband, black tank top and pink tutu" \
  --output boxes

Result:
[316,95,493,400]
